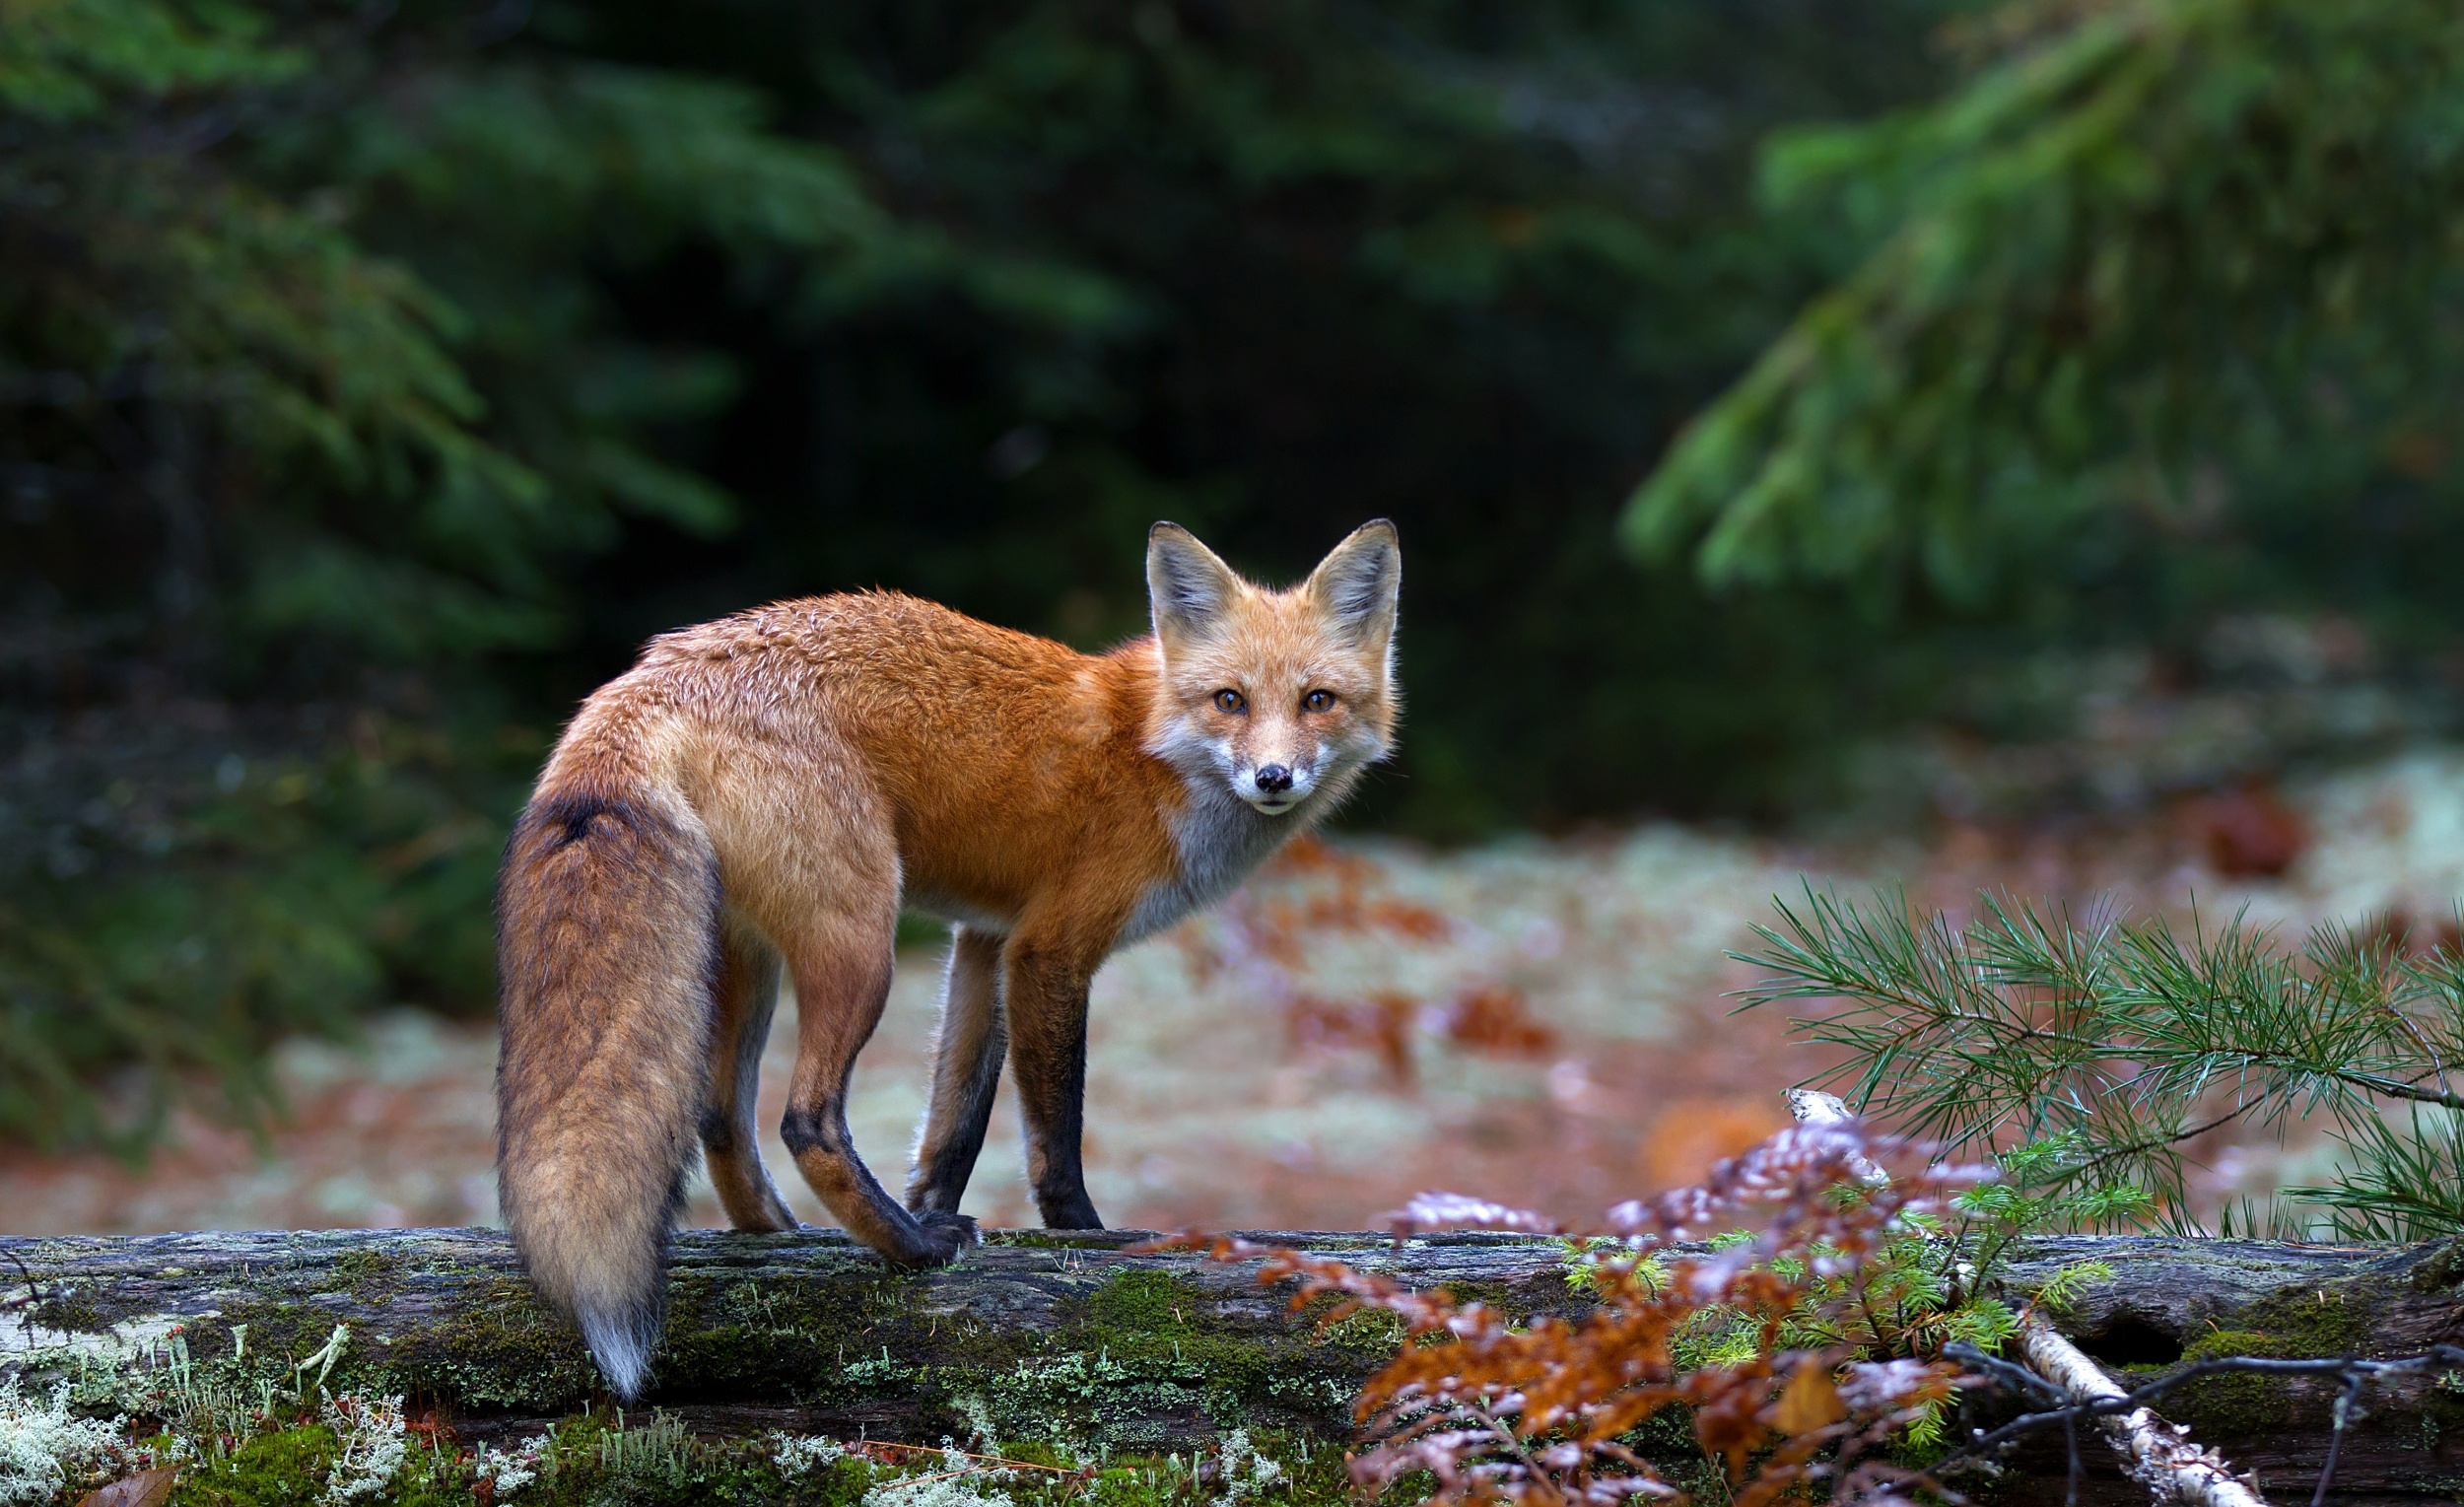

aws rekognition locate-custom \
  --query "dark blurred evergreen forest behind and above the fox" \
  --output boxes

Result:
[14,0,2464,1147]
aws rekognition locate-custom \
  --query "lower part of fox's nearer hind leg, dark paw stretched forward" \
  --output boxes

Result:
[779,901,976,1266]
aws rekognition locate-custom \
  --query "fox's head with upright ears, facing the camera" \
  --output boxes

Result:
[1146,519,1403,815]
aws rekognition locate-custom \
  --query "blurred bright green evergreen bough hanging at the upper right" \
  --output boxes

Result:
[1624,0,2464,651]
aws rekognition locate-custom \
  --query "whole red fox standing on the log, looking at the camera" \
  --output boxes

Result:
[498,519,1403,1399]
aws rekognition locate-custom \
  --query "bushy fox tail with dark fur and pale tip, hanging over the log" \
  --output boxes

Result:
[496,783,719,1402]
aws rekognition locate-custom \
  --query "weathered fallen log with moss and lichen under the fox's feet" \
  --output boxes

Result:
[0,1229,2464,1502]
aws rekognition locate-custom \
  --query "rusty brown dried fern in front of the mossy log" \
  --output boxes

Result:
[1186,1126,1974,1507]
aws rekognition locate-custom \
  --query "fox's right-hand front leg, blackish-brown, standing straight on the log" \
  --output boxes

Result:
[1003,935,1104,1229]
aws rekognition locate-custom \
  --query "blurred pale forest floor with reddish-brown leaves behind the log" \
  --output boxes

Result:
[0,751,2464,1234]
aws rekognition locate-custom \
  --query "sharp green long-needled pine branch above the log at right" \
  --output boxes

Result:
[1743,886,2464,1239]
